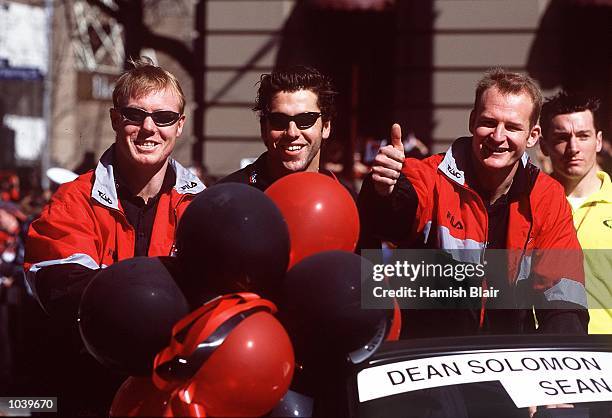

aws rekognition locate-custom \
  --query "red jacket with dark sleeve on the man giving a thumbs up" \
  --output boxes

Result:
[359,138,587,332]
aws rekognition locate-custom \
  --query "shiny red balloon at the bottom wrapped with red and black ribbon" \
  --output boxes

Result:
[153,293,294,417]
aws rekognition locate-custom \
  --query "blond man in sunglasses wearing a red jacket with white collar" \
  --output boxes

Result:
[25,60,204,415]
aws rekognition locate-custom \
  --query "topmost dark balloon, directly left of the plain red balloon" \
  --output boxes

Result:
[177,183,289,303]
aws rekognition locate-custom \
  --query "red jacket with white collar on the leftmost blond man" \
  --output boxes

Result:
[25,147,205,306]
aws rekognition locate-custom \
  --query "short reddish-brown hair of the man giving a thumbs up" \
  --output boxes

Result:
[474,67,543,128]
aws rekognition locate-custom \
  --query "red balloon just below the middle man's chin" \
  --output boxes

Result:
[266,172,359,268]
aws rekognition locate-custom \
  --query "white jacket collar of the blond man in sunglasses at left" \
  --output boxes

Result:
[91,144,206,210]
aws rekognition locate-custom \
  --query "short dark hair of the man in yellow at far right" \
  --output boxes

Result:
[540,90,601,139]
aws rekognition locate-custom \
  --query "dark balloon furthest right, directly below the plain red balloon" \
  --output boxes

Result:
[278,251,392,363]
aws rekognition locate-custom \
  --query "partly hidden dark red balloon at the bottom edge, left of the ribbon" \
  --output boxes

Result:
[109,376,173,417]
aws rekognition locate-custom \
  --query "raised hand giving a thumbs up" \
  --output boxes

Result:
[372,123,406,196]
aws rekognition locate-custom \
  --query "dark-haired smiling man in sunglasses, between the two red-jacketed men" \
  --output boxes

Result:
[221,66,336,191]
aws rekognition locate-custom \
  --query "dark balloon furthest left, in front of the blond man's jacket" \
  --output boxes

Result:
[79,257,189,375]
